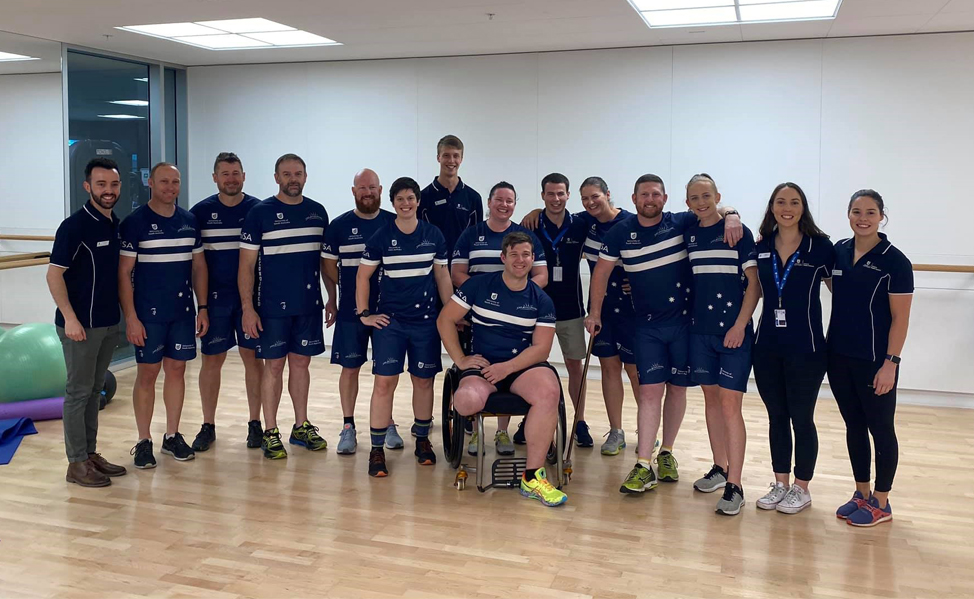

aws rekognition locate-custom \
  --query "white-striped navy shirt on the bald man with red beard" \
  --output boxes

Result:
[321,210,396,320]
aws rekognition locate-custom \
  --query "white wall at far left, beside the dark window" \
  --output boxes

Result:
[0,73,64,323]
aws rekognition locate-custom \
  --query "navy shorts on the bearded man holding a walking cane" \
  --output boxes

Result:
[630,321,694,387]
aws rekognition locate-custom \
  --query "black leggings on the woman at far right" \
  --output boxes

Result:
[829,352,899,493]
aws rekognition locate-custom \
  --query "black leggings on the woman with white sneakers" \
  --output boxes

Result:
[752,345,827,480]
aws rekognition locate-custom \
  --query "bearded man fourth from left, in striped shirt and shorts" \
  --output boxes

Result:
[237,154,335,460]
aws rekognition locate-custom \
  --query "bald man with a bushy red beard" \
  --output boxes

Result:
[321,169,396,455]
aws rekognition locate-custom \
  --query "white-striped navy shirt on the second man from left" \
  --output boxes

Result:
[119,204,203,322]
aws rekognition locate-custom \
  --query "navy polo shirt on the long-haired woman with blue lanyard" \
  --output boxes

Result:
[754,235,835,354]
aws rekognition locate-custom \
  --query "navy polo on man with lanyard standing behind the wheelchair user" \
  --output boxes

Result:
[535,211,588,320]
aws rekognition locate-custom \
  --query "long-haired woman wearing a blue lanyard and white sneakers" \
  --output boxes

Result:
[753,183,835,514]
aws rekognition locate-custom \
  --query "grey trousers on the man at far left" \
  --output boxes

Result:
[57,325,119,462]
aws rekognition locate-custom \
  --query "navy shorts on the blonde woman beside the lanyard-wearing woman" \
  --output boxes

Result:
[690,327,754,393]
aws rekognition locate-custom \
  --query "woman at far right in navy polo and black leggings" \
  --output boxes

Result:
[828,189,913,526]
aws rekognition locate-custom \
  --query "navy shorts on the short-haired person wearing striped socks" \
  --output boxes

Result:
[372,318,443,379]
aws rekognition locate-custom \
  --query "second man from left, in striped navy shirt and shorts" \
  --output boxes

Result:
[118,162,209,468]
